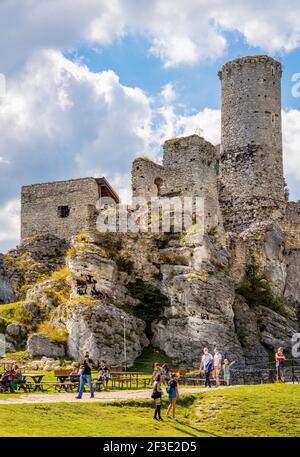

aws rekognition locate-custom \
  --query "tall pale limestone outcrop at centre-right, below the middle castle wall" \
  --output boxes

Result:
[152,236,244,368]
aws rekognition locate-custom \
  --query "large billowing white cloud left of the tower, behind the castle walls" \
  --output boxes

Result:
[0,50,223,248]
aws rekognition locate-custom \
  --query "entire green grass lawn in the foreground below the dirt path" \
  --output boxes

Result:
[0,384,300,437]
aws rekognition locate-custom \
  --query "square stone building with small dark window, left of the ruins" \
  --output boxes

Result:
[21,178,99,240]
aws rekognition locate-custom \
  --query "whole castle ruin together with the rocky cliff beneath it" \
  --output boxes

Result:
[0,56,300,370]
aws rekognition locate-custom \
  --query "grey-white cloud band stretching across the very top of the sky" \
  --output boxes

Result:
[0,0,300,72]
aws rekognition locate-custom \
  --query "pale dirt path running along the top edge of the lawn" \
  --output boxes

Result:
[0,387,220,405]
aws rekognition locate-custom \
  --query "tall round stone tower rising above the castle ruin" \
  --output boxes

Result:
[219,56,285,232]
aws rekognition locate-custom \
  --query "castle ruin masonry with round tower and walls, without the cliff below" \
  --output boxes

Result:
[21,56,300,248]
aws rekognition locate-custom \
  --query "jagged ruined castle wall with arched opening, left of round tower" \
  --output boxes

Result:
[132,135,222,235]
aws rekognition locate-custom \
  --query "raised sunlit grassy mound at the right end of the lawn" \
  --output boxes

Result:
[196,384,300,437]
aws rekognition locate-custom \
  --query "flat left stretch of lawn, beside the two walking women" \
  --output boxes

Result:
[0,396,202,437]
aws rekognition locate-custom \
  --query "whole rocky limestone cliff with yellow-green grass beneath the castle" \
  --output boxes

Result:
[0,218,300,368]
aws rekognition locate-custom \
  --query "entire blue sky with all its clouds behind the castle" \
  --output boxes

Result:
[0,0,300,252]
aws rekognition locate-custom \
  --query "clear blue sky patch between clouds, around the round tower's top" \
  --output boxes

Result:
[65,32,300,111]
